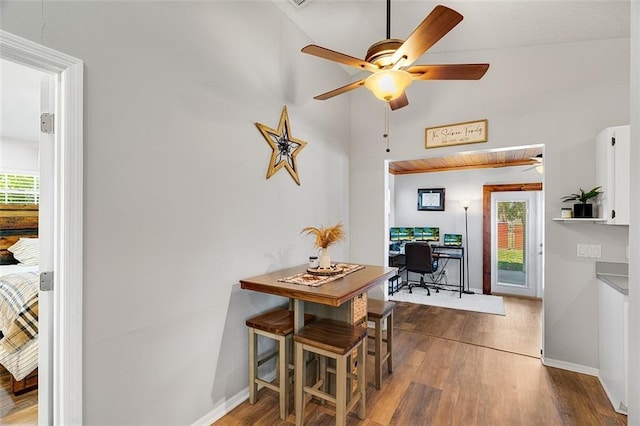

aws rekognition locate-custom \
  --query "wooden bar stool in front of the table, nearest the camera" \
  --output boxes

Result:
[293,319,367,425]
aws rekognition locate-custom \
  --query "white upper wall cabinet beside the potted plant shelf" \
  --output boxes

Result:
[596,125,631,225]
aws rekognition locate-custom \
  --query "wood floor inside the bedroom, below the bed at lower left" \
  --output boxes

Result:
[0,365,38,426]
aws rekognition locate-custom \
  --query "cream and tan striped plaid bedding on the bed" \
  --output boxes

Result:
[0,272,38,380]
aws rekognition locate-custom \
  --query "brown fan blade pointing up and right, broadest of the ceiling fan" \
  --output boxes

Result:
[391,5,463,67]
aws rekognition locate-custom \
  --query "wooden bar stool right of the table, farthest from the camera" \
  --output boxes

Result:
[367,299,396,389]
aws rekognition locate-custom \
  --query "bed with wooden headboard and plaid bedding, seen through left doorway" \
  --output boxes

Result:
[0,204,39,394]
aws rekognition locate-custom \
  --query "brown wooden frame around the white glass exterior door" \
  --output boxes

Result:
[482,182,542,294]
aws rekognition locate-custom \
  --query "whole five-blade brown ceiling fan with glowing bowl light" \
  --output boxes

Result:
[302,0,489,110]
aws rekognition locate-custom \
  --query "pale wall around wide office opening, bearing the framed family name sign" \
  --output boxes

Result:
[351,39,629,370]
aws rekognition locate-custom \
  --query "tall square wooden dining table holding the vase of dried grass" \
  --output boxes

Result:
[240,264,398,331]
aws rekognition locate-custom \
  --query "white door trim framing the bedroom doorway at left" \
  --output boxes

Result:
[0,30,84,425]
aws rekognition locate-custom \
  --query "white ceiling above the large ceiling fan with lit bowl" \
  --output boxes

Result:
[274,0,631,74]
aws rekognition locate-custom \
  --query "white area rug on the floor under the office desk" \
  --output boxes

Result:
[389,287,505,315]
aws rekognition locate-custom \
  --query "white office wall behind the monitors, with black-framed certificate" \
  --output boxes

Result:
[391,166,542,292]
